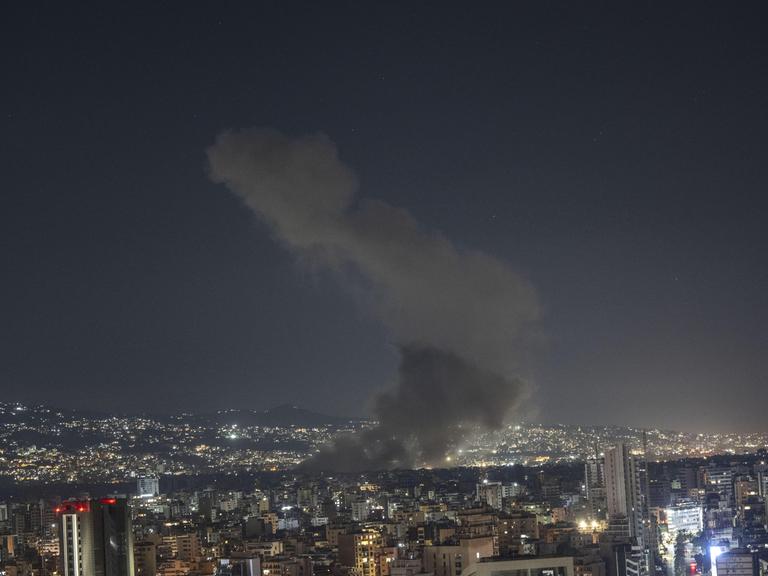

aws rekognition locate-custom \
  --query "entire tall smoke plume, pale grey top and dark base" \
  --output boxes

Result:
[208,130,538,470]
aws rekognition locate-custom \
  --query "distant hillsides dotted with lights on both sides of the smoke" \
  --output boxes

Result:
[0,403,768,486]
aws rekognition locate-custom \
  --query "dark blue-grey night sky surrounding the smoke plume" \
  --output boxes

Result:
[0,2,768,431]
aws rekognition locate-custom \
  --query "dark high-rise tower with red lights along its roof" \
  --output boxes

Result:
[56,498,134,576]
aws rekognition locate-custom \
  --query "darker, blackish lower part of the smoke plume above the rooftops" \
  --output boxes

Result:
[304,346,521,472]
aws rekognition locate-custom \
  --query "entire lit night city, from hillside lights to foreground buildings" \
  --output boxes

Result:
[7,403,768,576]
